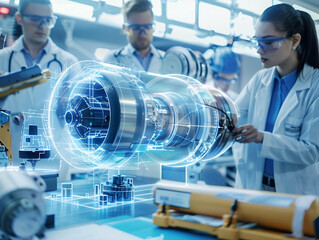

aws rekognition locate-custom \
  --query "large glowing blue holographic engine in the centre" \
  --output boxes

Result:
[49,61,237,169]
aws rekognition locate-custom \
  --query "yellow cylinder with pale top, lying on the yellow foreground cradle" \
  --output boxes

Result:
[154,181,319,236]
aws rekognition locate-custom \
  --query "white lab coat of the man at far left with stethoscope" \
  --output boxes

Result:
[0,36,78,167]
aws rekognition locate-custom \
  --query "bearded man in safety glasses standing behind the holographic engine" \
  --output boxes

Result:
[103,0,163,73]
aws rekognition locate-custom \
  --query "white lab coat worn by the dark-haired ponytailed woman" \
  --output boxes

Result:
[234,65,319,195]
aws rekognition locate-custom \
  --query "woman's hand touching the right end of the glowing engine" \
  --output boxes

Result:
[232,125,264,143]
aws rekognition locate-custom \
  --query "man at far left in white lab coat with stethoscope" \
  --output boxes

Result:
[0,0,77,167]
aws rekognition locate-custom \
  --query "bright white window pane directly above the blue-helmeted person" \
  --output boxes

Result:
[198,2,230,34]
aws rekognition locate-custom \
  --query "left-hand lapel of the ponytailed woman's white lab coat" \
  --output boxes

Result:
[254,70,275,131]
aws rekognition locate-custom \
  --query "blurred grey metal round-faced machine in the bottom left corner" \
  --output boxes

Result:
[0,170,46,240]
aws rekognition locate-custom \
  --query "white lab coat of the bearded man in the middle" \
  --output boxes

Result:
[103,44,164,73]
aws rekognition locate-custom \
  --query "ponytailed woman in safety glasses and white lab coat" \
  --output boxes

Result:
[234,4,319,195]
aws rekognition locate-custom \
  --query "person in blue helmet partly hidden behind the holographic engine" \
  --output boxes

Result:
[210,47,240,101]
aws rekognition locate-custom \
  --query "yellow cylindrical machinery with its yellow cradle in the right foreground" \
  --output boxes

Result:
[153,181,319,240]
